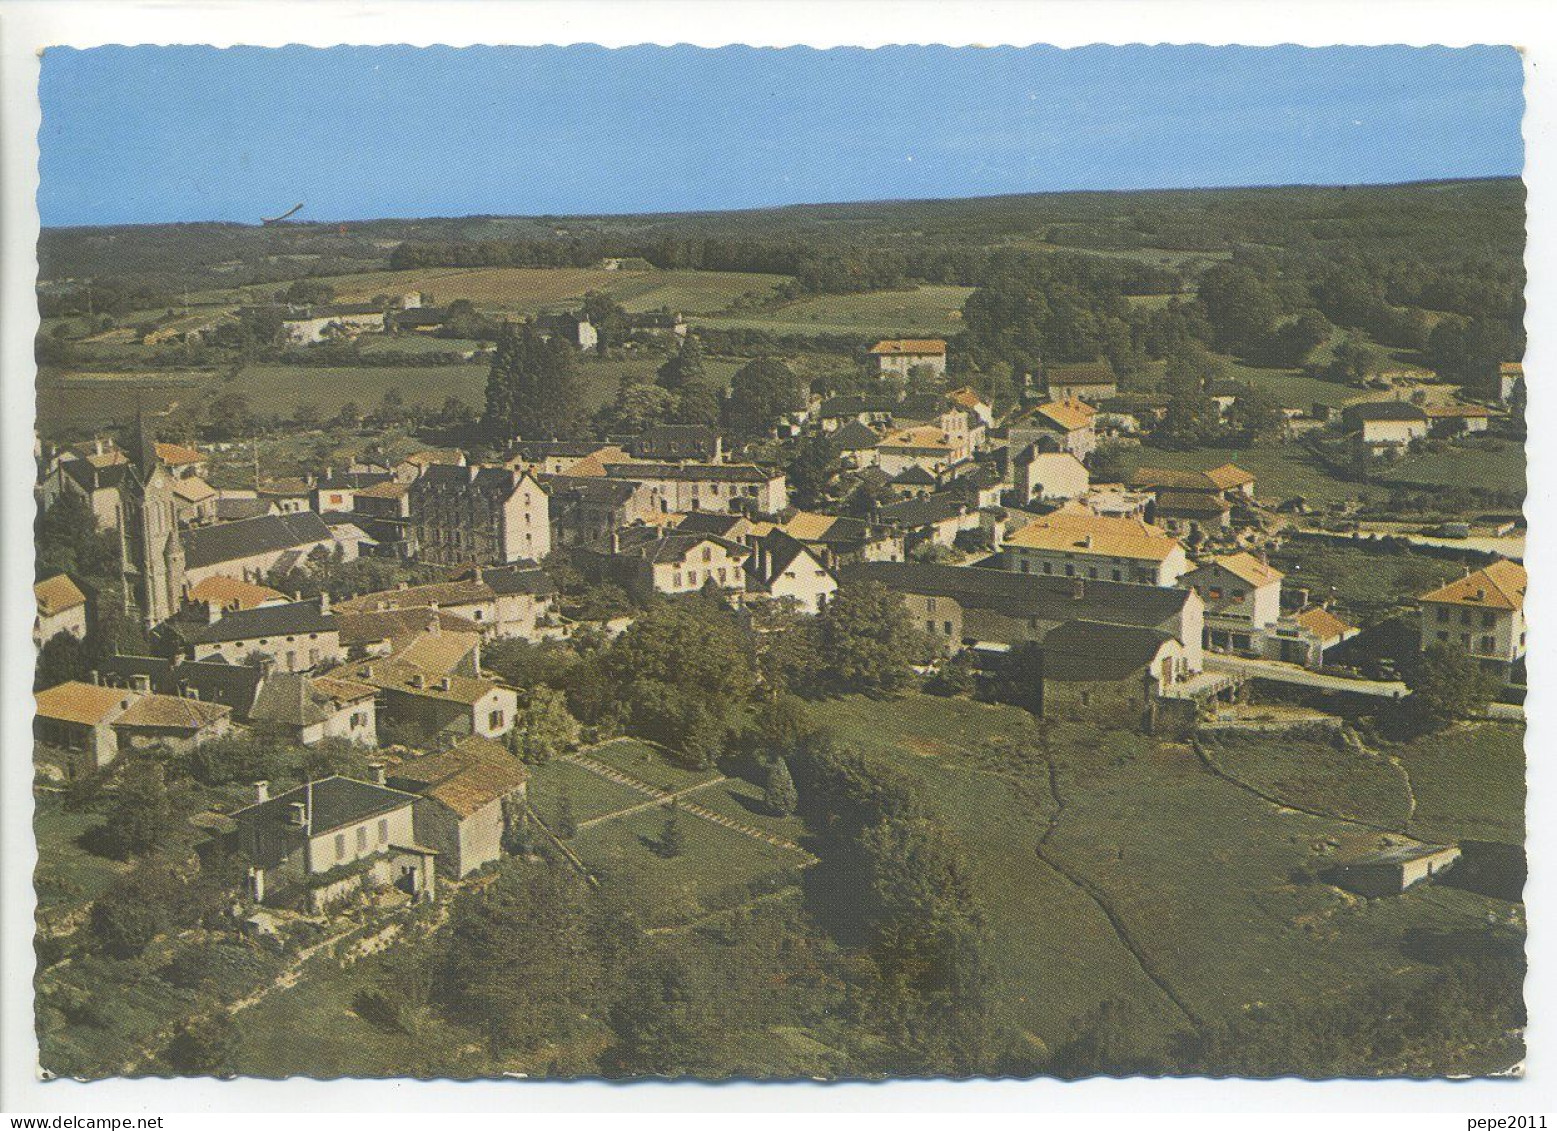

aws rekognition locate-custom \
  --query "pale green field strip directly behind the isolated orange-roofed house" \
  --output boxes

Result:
[694,287,973,338]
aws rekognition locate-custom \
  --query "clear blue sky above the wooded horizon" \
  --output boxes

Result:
[39,47,1523,226]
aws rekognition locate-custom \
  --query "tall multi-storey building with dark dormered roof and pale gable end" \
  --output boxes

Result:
[409,464,551,566]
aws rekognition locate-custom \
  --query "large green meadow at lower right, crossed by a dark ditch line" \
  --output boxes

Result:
[816,696,1521,1047]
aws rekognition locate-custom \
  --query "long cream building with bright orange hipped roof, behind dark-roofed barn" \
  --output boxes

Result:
[1003,505,1190,586]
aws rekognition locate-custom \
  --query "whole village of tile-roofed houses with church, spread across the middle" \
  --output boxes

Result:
[33,236,1526,1070]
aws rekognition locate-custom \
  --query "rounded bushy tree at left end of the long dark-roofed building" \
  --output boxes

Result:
[817,581,928,695]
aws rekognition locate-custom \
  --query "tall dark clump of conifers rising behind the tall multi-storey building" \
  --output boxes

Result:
[483,322,582,439]
